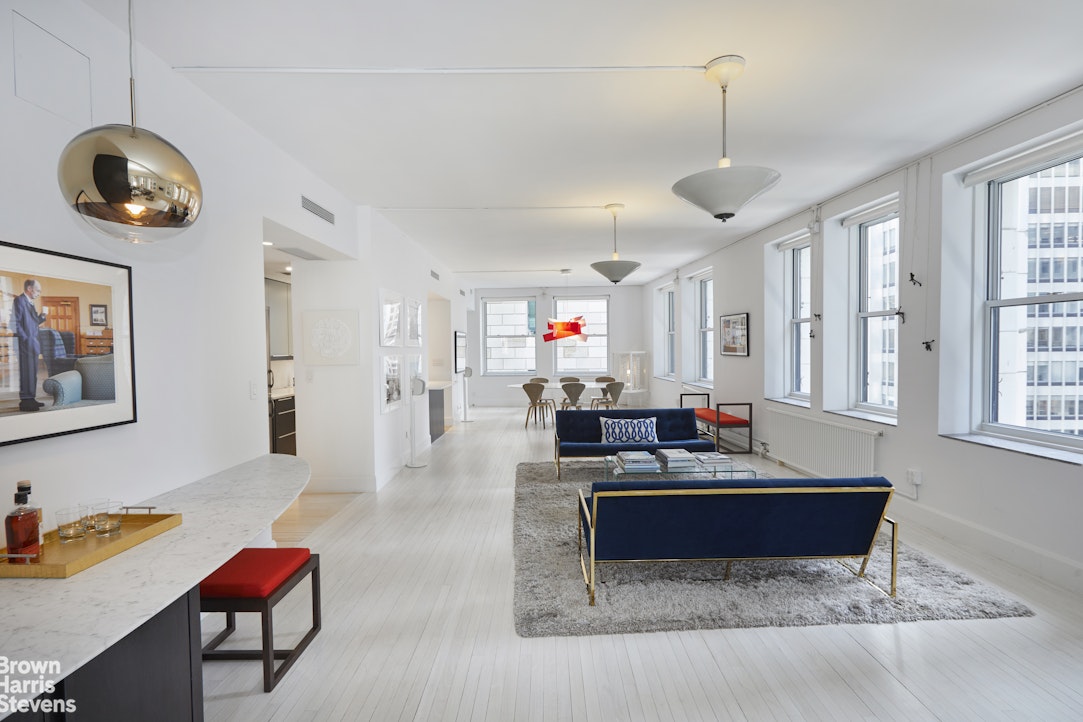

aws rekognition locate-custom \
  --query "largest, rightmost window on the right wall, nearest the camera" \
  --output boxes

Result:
[983,158,1083,446]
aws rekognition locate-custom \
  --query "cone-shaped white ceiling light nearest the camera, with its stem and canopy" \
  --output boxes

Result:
[673,55,782,222]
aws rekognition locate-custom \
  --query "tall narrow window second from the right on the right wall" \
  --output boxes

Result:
[858,213,899,412]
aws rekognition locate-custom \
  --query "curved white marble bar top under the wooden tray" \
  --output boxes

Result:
[0,454,310,697]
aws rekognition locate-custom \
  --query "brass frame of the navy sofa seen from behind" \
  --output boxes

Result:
[575,486,899,606]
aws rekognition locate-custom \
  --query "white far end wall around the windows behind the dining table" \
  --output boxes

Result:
[472,285,648,406]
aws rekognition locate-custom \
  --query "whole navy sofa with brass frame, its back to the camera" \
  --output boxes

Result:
[578,476,898,605]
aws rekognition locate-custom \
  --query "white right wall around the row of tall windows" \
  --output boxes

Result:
[642,86,1083,591]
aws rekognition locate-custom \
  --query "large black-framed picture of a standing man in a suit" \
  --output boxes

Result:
[0,241,136,446]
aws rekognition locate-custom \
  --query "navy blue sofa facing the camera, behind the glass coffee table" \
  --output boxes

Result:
[553,408,715,478]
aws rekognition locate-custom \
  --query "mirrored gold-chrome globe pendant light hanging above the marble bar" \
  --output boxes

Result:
[57,0,203,244]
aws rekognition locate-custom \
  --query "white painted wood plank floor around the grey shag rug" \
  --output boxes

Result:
[204,408,1083,722]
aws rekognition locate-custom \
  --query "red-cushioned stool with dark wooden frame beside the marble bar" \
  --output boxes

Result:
[199,549,319,692]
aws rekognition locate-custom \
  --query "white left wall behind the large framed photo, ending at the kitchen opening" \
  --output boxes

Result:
[0,0,354,519]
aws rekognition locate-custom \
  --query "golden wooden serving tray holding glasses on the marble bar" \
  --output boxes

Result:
[0,514,181,579]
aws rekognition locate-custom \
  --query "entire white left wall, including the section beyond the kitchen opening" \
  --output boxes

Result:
[0,0,466,512]
